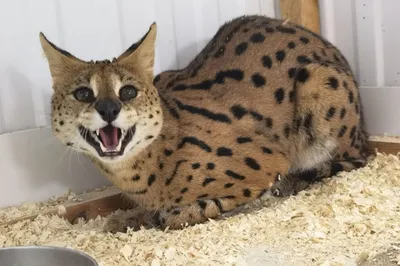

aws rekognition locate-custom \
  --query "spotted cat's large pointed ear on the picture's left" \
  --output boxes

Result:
[39,32,86,79]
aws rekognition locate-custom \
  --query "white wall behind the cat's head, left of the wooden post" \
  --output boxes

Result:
[0,0,275,206]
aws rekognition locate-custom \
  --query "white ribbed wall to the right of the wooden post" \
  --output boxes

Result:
[320,0,400,135]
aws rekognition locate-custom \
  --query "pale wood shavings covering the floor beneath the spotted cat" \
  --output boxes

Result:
[0,154,400,266]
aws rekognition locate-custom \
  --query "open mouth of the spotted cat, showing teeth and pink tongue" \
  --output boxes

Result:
[79,125,136,157]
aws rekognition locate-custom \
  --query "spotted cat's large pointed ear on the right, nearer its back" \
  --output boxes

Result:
[117,22,157,81]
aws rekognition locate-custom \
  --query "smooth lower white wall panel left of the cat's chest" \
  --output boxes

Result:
[0,127,109,207]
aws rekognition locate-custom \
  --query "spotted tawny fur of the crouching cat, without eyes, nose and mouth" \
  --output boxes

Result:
[42,16,366,231]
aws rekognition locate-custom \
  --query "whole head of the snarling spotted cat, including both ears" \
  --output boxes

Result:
[40,23,163,162]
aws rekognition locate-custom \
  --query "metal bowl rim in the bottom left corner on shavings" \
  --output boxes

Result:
[0,246,99,266]
